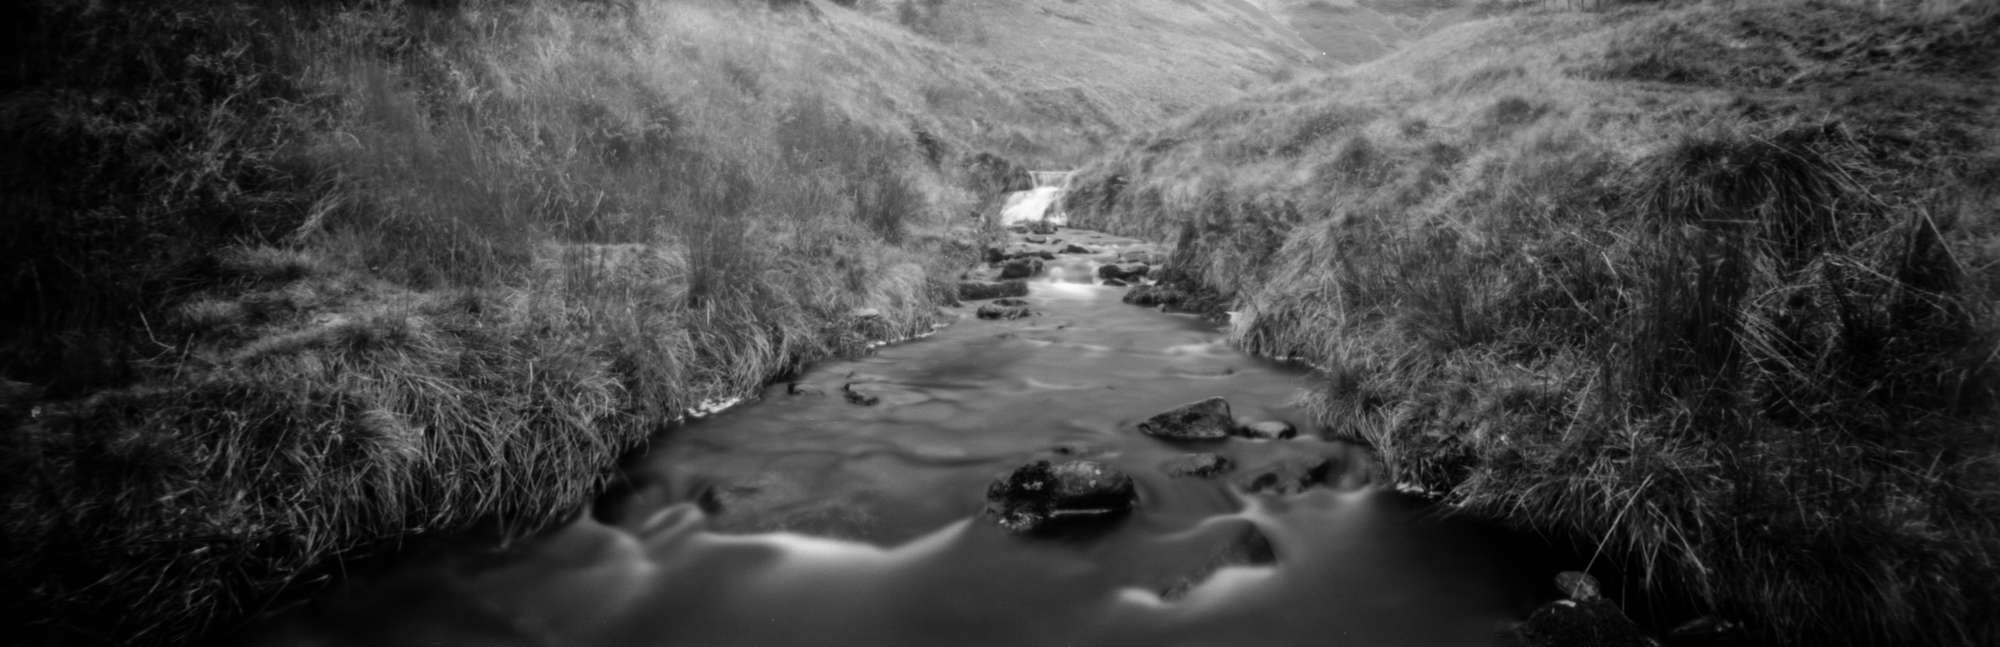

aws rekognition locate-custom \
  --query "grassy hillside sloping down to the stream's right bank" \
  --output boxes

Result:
[1068,2,2000,645]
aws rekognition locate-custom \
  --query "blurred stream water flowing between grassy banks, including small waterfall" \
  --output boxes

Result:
[254,230,1550,647]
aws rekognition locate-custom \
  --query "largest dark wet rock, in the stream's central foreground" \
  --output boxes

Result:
[986,459,1138,533]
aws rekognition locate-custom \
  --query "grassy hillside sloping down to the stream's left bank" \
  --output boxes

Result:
[0,0,1108,643]
